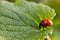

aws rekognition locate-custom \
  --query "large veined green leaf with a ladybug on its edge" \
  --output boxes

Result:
[0,1,55,40]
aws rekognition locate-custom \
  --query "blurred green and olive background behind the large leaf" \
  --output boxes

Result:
[1,0,60,40]
